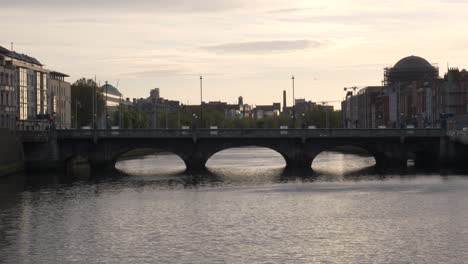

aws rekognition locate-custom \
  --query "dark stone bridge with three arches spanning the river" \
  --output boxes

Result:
[21,129,468,172]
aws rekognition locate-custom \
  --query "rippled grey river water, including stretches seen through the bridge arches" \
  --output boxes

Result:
[0,148,468,263]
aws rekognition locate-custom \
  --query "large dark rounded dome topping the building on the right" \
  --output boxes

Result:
[389,56,439,82]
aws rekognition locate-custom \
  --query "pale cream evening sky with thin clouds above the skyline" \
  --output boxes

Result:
[0,0,468,106]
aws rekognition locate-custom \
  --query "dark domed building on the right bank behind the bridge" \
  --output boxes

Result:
[342,56,450,128]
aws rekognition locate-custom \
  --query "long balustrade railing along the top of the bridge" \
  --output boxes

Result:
[53,129,445,139]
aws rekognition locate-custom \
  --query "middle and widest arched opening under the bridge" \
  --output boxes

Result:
[206,146,286,182]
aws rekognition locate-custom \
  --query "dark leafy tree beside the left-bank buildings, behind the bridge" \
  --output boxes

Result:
[71,78,105,128]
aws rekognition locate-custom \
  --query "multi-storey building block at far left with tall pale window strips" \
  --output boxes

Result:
[0,47,71,130]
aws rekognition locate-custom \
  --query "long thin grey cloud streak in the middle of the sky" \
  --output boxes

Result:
[202,39,324,54]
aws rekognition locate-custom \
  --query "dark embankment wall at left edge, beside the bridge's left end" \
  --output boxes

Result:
[0,128,23,176]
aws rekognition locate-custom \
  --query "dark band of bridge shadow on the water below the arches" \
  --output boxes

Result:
[5,166,467,194]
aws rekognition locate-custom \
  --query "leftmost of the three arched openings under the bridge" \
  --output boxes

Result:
[115,148,185,176]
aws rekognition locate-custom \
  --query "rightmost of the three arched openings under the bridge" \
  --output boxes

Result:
[312,145,376,176]
